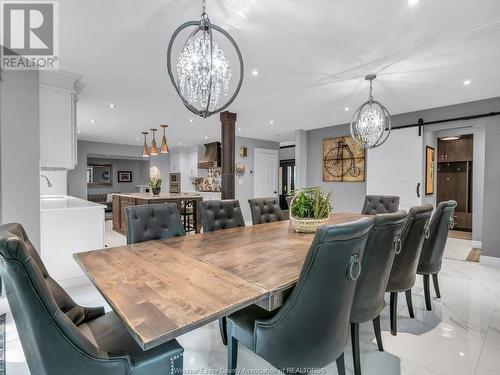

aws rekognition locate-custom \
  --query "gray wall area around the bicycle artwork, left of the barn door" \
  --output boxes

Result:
[307,124,366,212]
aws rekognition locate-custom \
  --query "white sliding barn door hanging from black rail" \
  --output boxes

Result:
[366,127,424,211]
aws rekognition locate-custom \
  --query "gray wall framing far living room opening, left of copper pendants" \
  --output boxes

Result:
[68,141,142,199]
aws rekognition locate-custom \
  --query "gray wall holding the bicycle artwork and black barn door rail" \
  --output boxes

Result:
[307,97,500,257]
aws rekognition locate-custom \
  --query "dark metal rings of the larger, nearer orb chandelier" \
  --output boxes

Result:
[167,17,244,118]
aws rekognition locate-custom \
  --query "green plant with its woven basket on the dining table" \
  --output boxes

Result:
[290,186,332,233]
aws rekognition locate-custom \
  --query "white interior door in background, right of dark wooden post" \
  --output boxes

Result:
[253,148,279,198]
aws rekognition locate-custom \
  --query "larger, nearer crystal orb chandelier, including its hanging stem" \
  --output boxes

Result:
[167,0,244,118]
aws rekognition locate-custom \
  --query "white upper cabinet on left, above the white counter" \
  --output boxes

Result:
[39,71,81,169]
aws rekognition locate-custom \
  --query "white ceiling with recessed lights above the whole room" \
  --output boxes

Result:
[59,0,500,146]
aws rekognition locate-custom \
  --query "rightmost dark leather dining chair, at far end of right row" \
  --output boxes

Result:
[417,200,457,311]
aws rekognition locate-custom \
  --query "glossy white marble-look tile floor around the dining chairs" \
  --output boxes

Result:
[0,240,500,375]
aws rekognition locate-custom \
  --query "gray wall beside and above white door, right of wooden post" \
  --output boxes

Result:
[235,137,280,221]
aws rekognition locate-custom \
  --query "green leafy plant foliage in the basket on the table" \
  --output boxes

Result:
[290,186,332,219]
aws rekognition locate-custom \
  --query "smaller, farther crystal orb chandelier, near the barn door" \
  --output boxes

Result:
[351,74,391,149]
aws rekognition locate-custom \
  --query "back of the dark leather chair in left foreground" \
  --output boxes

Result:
[0,224,130,375]
